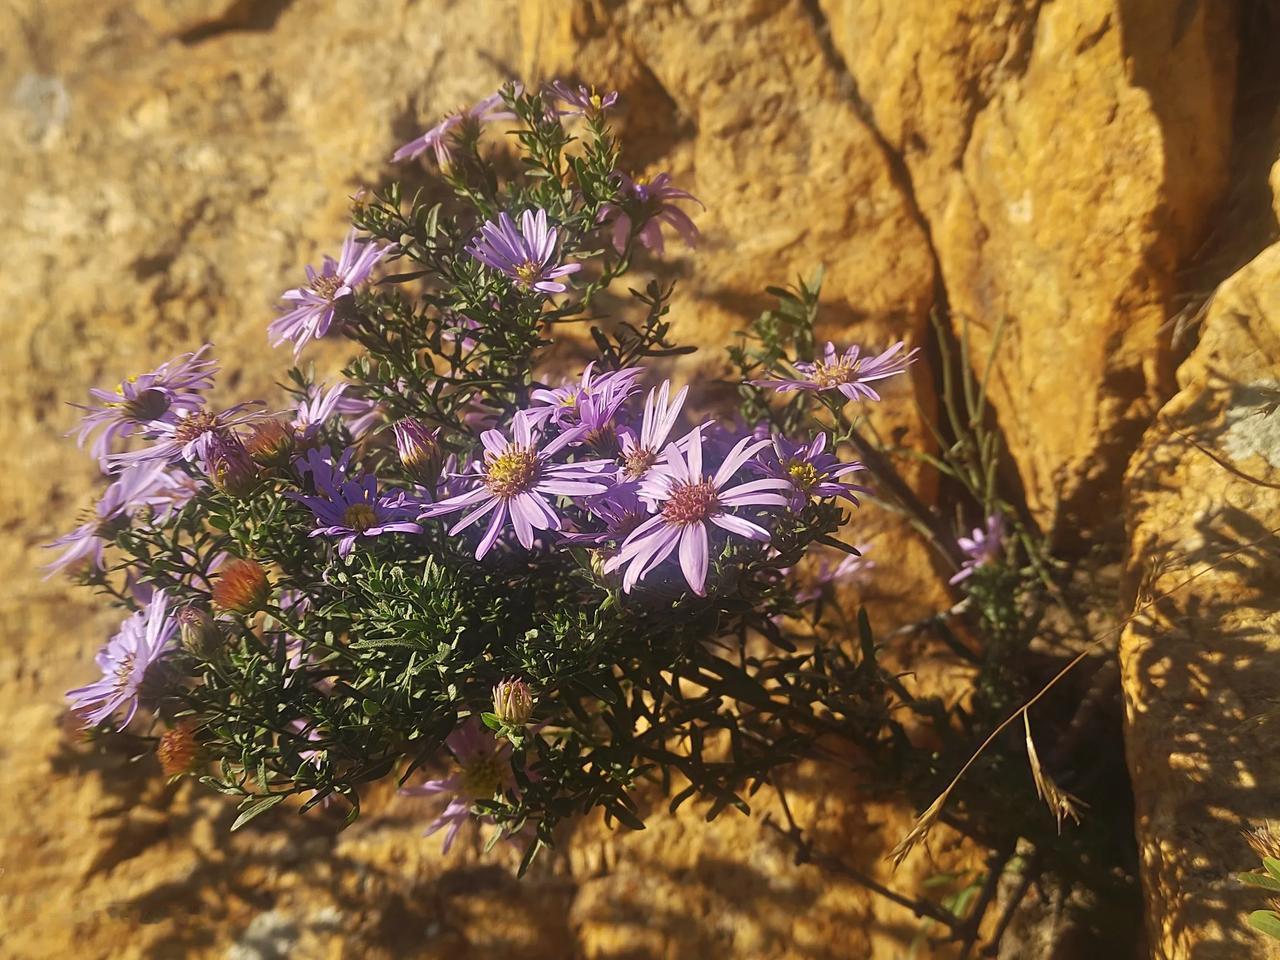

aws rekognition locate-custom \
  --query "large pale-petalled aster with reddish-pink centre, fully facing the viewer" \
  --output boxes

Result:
[604,426,790,596]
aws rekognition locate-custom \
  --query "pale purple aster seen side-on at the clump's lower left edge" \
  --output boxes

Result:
[67,590,178,730]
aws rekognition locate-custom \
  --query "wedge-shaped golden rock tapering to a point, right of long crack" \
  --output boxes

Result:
[820,0,1235,539]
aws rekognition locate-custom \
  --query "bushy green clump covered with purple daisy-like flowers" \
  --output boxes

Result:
[54,84,931,864]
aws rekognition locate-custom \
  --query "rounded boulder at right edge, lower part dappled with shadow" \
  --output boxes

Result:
[1121,235,1280,960]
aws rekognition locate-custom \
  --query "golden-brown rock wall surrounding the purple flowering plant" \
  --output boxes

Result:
[0,0,1280,960]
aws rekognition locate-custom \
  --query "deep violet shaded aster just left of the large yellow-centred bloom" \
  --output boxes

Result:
[288,449,422,557]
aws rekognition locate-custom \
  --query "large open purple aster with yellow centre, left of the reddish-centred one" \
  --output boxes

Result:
[422,411,609,559]
